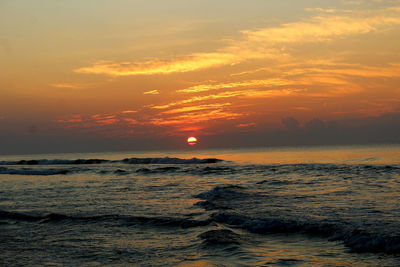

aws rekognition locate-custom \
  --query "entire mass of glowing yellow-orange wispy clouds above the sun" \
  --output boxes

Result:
[55,4,400,138]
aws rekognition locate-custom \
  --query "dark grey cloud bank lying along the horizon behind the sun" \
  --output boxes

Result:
[0,112,400,155]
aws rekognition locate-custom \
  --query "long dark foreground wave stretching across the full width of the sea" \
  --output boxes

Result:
[0,200,400,254]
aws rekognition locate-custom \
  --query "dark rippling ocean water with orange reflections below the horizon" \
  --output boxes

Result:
[0,145,400,266]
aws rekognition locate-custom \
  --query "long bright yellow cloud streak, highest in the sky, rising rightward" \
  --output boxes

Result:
[75,7,400,76]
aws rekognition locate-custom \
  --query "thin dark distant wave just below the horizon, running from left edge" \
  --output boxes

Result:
[0,157,223,165]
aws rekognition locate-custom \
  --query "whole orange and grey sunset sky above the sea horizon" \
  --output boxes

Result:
[0,0,400,154]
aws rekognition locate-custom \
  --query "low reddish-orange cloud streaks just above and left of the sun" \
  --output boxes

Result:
[56,103,242,136]
